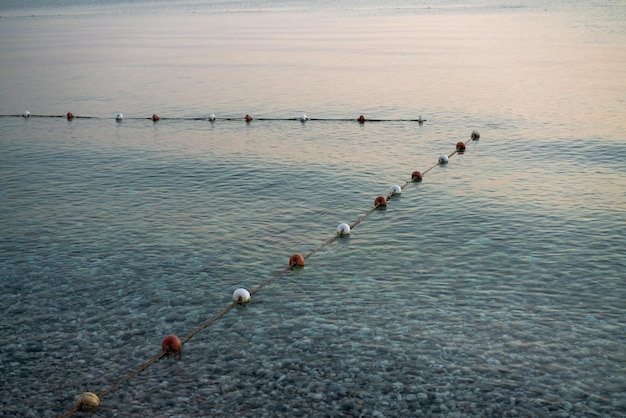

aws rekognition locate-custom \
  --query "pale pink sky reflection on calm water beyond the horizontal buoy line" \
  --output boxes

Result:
[0,4,626,136]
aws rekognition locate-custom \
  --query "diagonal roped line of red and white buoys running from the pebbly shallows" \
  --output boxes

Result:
[59,130,480,418]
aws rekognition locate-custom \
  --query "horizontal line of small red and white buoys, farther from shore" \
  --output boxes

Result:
[6,110,426,125]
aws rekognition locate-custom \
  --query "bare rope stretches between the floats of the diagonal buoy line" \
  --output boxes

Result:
[56,132,472,418]
